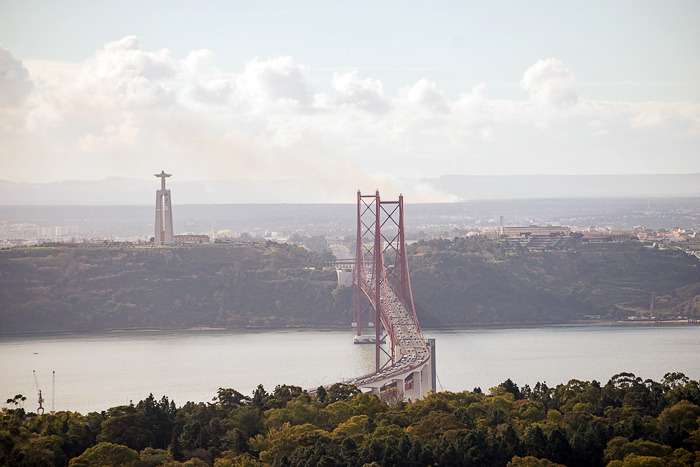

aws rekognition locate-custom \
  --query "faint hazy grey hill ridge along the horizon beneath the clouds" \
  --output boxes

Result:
[0,174,700,206]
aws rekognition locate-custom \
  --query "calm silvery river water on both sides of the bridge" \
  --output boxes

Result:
[0,325,700,413]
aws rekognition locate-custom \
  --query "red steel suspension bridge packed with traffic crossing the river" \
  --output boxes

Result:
[338,190,436,400]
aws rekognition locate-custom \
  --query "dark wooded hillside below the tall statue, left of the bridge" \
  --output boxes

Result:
[0,242,352,334]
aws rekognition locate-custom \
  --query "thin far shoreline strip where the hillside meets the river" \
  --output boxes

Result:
[0,319,700,338]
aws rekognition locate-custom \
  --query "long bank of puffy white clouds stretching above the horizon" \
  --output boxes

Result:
[0,36,700,200]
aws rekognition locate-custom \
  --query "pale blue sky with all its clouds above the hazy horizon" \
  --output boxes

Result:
[0,0,700,201]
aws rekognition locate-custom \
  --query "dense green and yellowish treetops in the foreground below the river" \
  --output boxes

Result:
[0,373,700,467]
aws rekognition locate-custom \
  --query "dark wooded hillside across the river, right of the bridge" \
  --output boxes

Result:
[408,237,700,327]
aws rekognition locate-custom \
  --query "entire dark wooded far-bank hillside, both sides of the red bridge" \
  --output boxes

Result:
[0,236,700,334]
